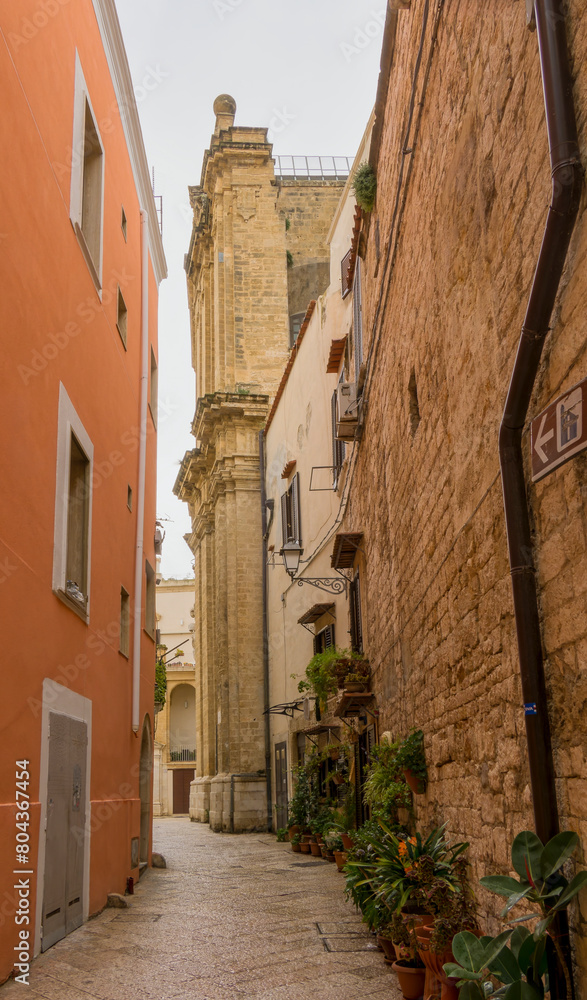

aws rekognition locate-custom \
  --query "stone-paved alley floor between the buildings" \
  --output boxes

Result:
[0,817,401,1000]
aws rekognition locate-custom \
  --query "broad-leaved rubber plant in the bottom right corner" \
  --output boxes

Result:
[444,830,587,1000]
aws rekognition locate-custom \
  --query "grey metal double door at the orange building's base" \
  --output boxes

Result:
[42,712,88,951]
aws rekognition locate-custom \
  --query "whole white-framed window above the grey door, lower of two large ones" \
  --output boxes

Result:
[53,385,94,621]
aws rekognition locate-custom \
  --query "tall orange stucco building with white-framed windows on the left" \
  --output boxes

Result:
[0,0,166,982]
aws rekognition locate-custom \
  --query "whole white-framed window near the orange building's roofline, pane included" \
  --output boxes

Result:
[69,53,104,291]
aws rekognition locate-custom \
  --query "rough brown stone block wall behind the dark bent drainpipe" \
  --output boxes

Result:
[344,0,587,984]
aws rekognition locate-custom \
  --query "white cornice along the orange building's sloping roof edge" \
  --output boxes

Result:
[93,0,167,284]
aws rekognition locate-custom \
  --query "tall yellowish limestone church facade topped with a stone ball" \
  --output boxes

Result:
[174,95,345,832]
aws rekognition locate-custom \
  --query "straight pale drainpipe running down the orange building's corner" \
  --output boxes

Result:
[132,211,149,733]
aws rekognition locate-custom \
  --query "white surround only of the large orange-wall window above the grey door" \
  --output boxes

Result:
[53,382,94,622]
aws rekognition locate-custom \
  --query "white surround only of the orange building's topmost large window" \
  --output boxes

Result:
[69,50,105,298]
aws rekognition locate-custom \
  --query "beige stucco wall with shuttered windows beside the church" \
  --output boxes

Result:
[265,121,372,820]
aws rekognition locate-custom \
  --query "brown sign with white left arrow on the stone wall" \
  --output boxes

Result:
[531,379,587,483]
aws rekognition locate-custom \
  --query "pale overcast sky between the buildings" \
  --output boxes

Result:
[117,0,386,577]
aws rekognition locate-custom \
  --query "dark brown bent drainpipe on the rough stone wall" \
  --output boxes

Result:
[499,0,583,1000]
